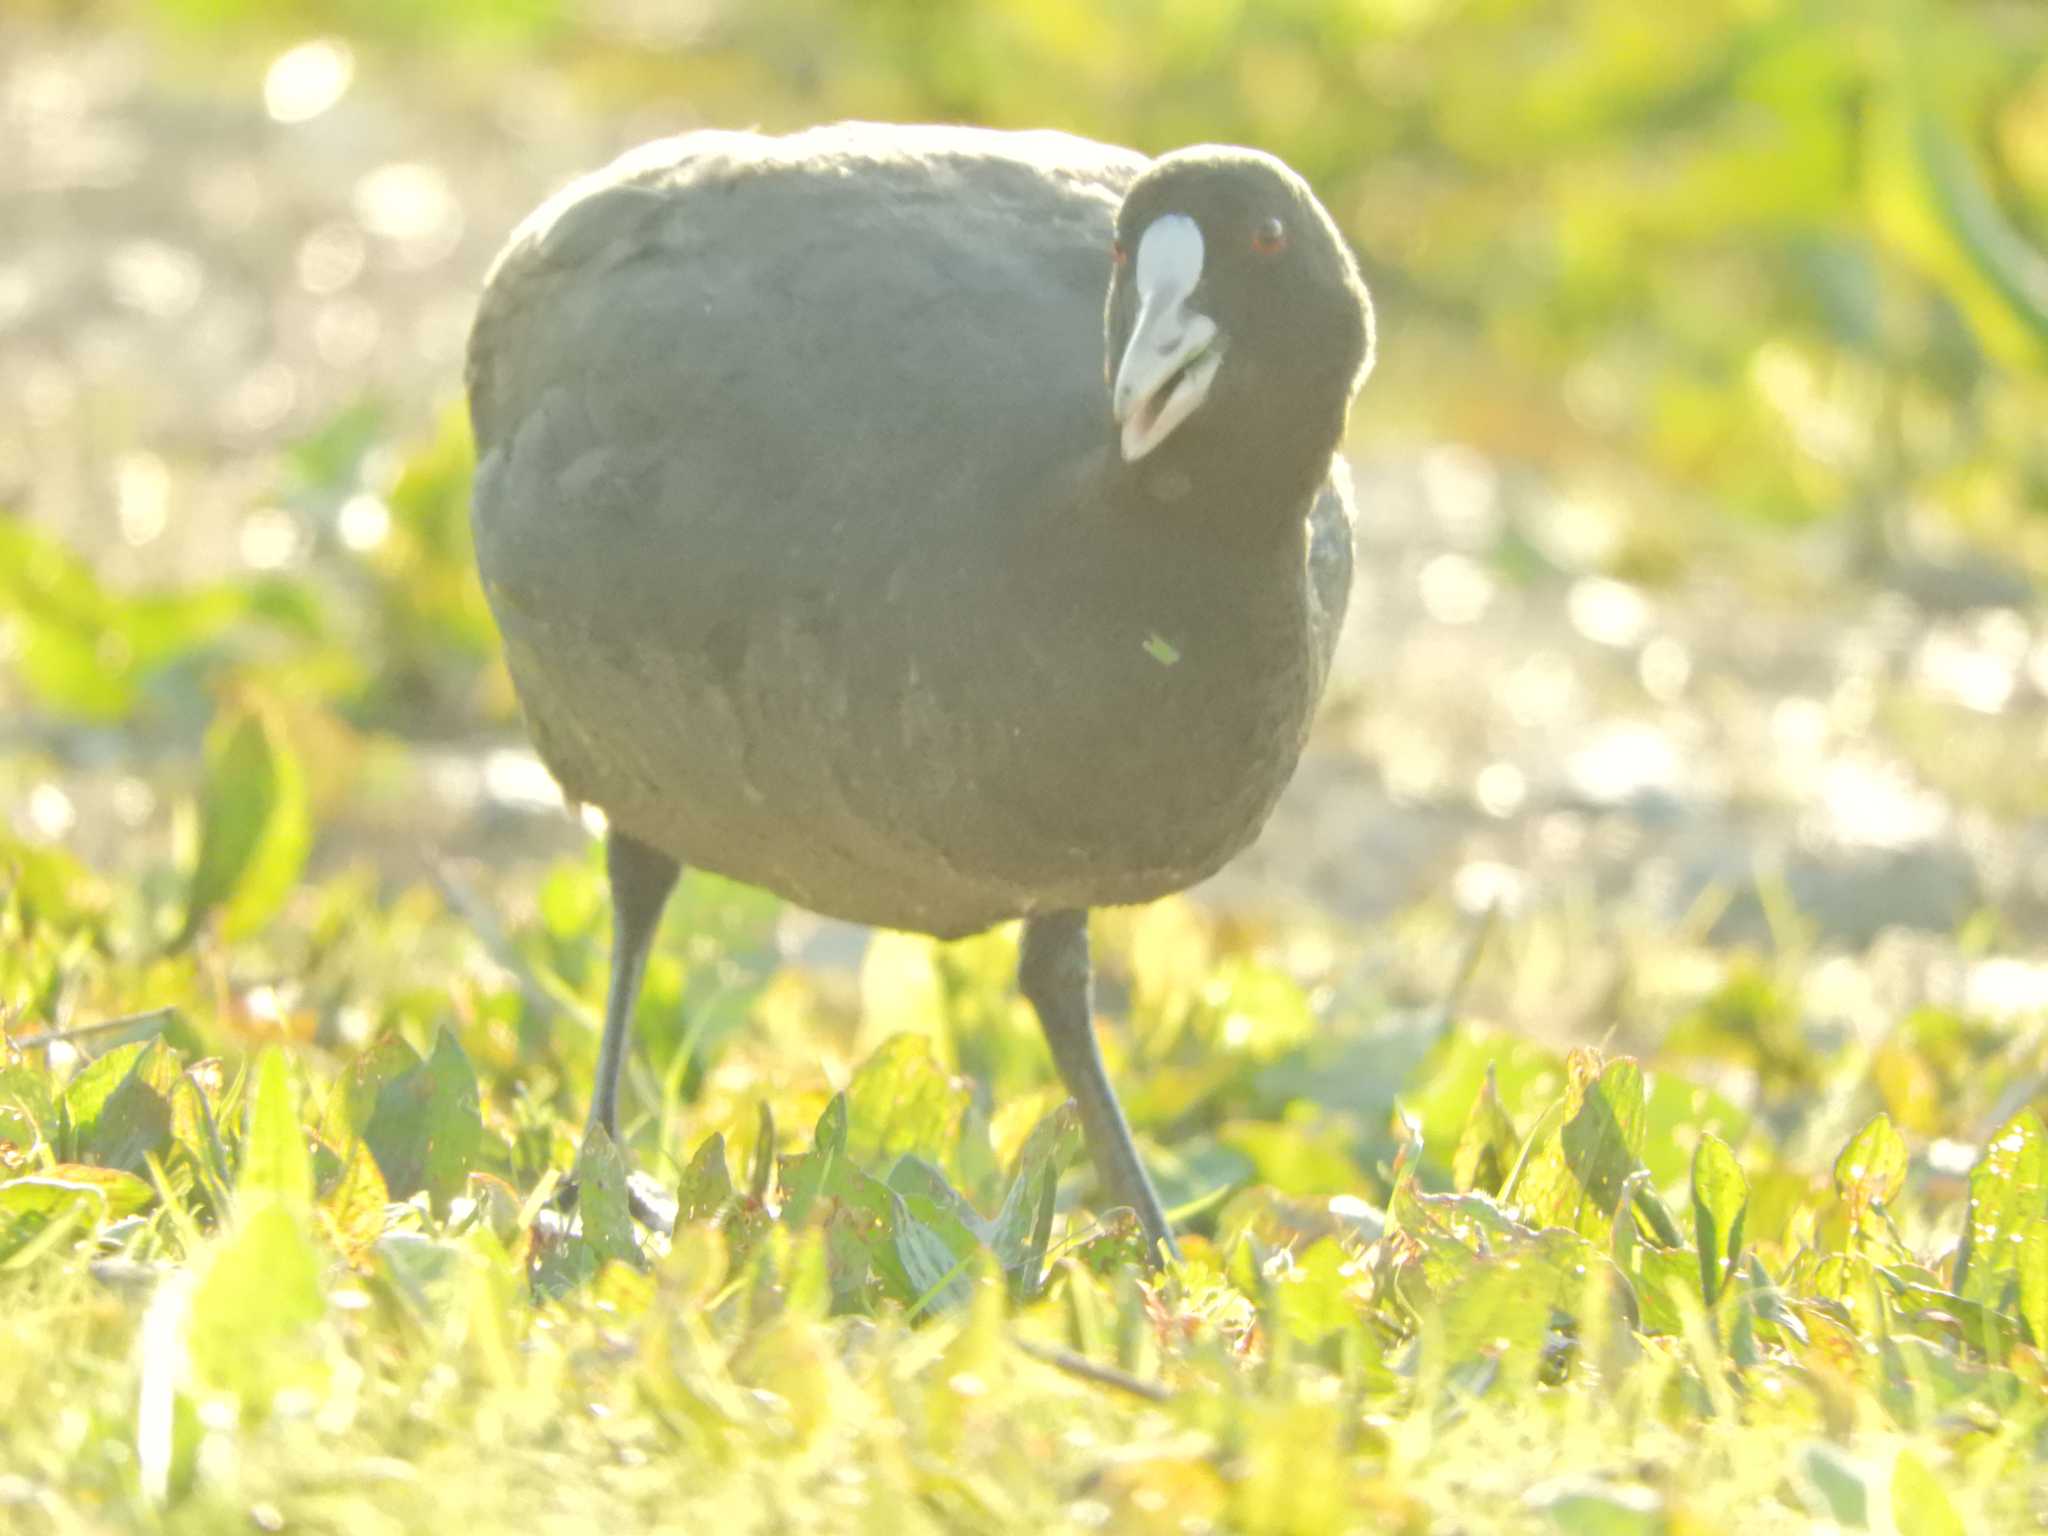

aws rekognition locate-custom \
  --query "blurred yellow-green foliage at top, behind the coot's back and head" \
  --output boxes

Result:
[113,0,2048,567]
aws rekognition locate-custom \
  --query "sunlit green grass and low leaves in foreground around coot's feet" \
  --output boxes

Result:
[0,819,2048,1536]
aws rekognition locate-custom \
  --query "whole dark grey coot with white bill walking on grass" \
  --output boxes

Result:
[469,123,1372,1253]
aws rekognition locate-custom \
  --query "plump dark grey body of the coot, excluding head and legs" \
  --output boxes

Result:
[469,125,1348,934]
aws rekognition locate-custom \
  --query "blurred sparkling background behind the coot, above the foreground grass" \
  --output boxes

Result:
[0,0,2048,1073]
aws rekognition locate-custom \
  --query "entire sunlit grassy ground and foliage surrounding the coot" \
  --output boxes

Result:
[0,12,2048,1536]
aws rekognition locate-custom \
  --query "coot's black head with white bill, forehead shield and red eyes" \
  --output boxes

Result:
[1106,145,1372,522]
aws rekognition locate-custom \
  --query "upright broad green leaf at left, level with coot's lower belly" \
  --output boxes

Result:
[172,705,311,948]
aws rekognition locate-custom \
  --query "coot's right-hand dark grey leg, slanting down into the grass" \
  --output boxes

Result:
[1018,911,1180,1264]
